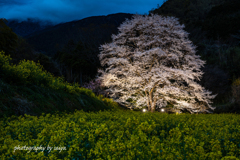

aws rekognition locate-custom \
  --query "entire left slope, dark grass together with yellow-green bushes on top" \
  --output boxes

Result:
[0,52,129,118]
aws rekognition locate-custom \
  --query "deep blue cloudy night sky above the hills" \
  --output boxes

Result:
[0,0,164,23]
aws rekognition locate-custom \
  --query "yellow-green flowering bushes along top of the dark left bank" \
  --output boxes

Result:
[0,52,79,93]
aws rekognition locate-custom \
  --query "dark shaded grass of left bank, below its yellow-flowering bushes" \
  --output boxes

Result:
[0,79,127,121]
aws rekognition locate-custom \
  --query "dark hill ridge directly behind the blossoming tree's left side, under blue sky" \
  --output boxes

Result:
[26,13,132,57]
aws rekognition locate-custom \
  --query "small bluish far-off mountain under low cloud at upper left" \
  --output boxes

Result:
[7,18,53,37]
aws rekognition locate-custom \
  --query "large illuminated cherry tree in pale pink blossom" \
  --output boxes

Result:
[97,14,216,113]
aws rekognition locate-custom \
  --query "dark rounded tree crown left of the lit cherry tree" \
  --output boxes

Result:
[54,40,100,85]
